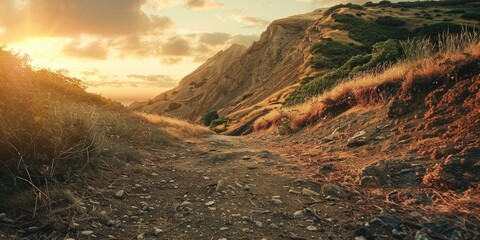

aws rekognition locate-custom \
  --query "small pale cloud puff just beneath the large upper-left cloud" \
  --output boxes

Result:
[62,40,108,60]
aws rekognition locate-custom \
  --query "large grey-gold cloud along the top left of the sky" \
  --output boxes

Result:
[0,0,173,39]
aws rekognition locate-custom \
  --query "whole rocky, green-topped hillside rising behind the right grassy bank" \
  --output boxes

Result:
[131,1,479,135]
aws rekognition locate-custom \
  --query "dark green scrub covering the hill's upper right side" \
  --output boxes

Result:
[286,0,478,105]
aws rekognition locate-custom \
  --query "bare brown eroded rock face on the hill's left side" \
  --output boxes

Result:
[130,12,321,122]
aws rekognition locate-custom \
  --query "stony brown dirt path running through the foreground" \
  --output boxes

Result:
[68,135,357,239]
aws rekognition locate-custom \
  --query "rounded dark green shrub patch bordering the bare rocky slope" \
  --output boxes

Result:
[310,39,362,69]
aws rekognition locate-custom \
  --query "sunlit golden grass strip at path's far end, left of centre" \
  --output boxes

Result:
[135,112,212,138]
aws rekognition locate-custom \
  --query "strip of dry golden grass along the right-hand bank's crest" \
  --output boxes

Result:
[254,34,480,131]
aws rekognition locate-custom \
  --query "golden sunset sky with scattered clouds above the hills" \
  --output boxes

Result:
[0,0,368,104]
